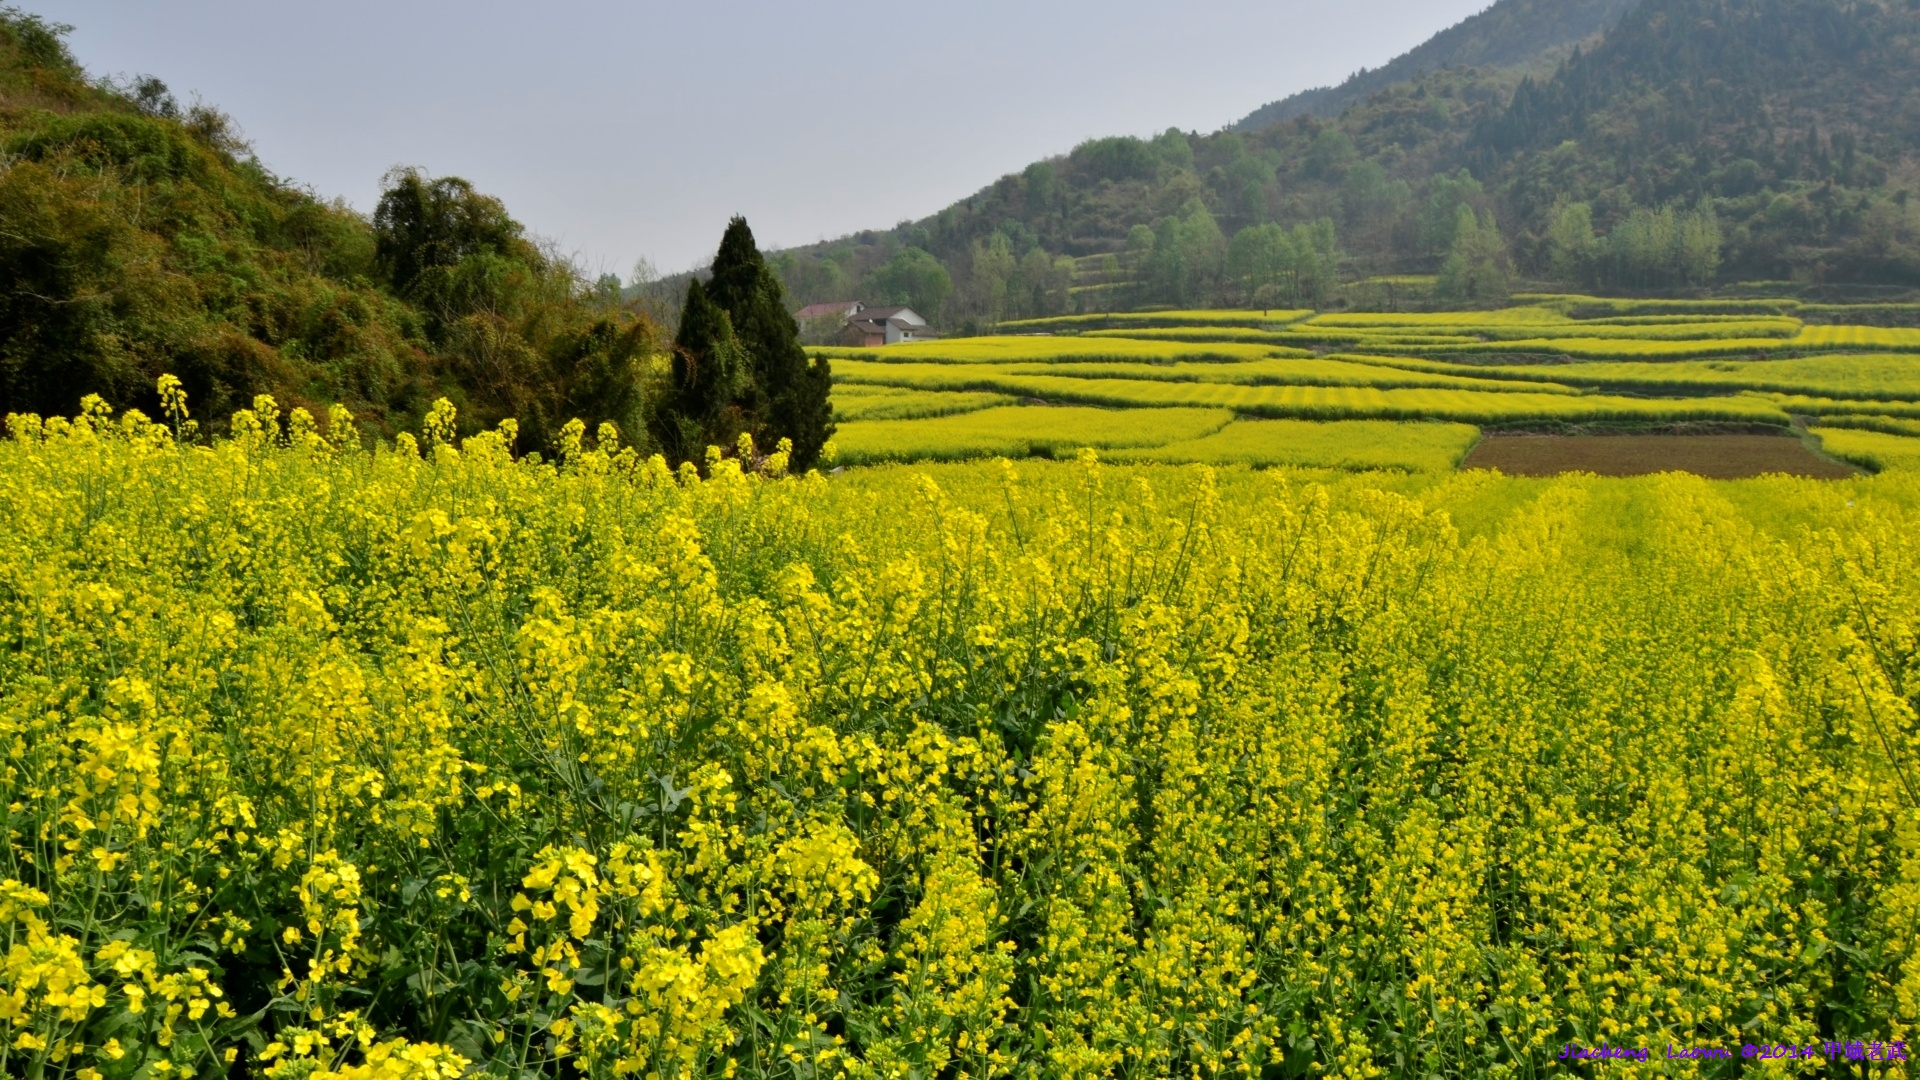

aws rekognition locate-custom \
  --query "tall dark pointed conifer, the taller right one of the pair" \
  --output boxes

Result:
[707,217,833,471]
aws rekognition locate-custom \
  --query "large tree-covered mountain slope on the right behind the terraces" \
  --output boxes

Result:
[778,0,1920,329]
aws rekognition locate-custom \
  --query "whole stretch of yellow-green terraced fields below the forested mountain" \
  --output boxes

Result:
[820,296,1920,475]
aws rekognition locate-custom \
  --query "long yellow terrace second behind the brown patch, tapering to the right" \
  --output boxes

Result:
[833,359,1582,394]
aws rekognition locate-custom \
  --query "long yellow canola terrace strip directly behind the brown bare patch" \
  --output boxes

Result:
[837,369,1789,425]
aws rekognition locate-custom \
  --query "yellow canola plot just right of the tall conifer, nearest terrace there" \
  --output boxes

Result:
[833,405,1233,465]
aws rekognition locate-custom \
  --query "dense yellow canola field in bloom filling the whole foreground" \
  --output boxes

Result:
[11,394,1920,1080]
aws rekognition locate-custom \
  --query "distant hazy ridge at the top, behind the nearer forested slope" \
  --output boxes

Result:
[1233,0,1640,131]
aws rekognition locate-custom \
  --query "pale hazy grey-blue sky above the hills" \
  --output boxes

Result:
[41,0,1490,275]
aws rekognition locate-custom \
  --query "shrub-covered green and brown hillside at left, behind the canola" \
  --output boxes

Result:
[0,10,657,438]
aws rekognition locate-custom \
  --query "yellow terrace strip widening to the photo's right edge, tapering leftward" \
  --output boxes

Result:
[1329,354,1920,399]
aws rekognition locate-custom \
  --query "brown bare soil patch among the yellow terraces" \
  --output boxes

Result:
[1461,434,1859,480]
